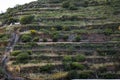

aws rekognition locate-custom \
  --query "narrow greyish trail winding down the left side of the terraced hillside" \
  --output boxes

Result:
[2,30,25,80]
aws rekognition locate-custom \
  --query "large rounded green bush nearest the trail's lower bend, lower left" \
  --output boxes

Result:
[16,52,29,63]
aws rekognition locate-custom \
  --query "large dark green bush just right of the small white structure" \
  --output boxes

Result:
[20,15,34,24]
